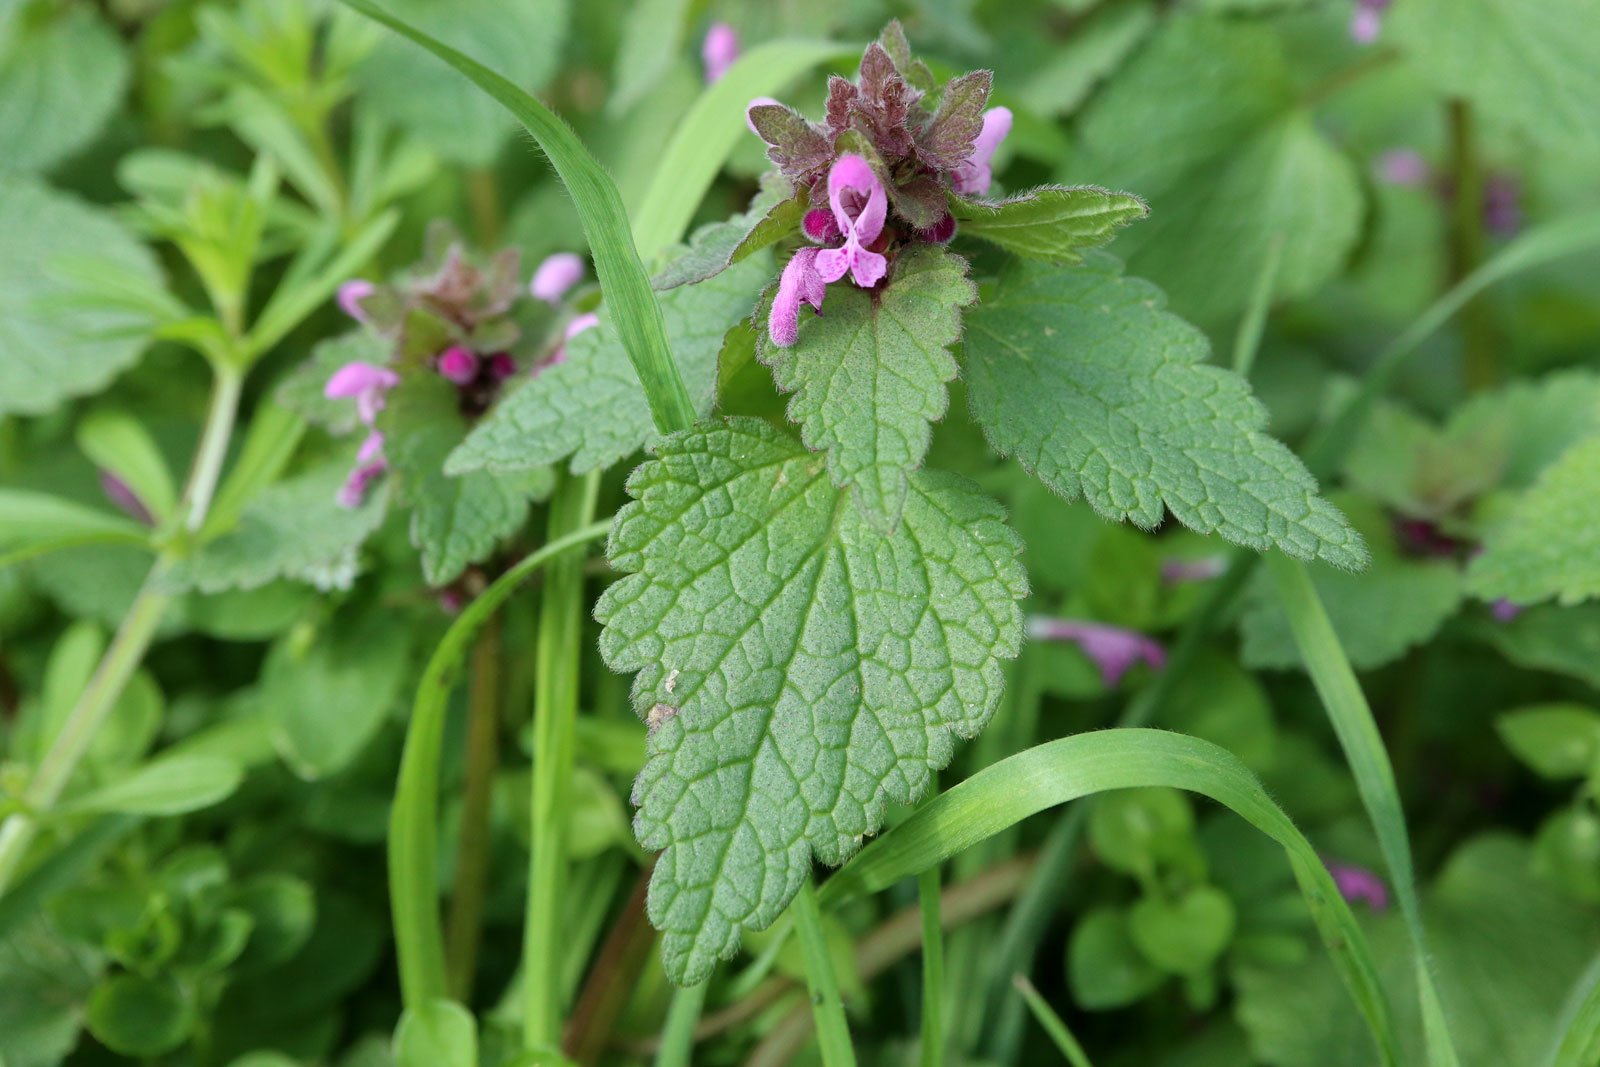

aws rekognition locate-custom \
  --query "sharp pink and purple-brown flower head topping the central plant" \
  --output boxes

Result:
[746,22,1011,347]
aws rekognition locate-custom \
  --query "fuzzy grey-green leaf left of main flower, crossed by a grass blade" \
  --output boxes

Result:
[445,256,771,475]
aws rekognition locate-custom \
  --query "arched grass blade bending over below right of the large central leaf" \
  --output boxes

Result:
[821,729,1400,1067]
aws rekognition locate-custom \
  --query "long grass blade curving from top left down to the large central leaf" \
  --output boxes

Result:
[344,0,694,434]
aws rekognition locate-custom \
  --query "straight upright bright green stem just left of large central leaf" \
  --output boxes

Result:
[523,474,600,1054]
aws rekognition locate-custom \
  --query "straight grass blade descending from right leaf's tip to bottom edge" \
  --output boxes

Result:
[1267,553,1461,1067]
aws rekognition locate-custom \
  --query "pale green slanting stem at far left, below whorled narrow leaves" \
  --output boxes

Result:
[0,366,242,896]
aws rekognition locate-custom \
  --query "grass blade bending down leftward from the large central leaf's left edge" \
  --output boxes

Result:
[389,520,611,1008]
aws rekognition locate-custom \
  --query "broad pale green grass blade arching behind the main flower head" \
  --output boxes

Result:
[634,40,861,259]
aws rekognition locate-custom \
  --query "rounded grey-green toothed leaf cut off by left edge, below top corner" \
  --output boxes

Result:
[0,178,162,414]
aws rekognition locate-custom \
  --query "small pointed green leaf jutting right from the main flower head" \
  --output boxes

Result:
[950,186,1150,264]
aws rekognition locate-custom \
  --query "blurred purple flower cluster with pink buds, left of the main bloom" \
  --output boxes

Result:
[323,235,595,507]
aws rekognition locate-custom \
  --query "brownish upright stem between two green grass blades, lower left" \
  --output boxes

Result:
[445,616,501,1005]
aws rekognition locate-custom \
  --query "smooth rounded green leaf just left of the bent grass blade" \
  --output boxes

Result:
[261,611,411,781]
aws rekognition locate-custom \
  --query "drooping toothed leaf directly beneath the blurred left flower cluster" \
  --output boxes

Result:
[379,379,550,585]
